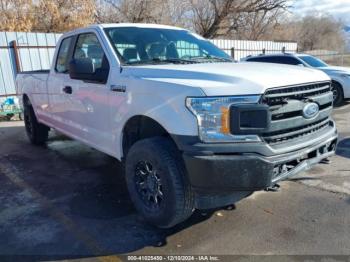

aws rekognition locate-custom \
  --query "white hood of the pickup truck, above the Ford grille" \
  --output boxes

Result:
[125,62,330,96]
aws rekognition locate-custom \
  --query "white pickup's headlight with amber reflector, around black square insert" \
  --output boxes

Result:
[186,95,261,143]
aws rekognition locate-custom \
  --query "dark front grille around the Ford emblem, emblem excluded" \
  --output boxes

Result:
[262,82,332,145]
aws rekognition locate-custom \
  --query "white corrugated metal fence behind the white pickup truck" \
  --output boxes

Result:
[0,32,297,98]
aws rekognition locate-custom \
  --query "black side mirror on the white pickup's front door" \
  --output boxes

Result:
[69,58,109,83]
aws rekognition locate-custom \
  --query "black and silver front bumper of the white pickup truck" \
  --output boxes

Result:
[175,127,337,195]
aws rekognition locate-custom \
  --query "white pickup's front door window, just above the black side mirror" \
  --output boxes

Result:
[73,33,107,71]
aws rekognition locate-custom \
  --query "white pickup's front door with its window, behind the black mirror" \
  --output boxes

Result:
[65,32,112,153]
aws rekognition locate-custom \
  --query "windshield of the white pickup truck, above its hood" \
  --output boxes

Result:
[105,27,233,65]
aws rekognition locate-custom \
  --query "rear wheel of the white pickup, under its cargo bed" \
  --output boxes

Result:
[23,100,50,145]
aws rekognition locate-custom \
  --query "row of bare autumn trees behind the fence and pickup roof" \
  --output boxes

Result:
[0,0,345,53]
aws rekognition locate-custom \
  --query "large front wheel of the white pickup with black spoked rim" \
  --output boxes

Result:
[125,137,194,228]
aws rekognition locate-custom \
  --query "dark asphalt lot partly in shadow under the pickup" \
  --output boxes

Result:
[0,104,350,260]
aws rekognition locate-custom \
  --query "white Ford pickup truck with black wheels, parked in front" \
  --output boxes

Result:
[17,24,337,227]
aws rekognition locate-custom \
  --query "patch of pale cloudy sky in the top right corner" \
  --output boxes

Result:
[292,0,350,25]
